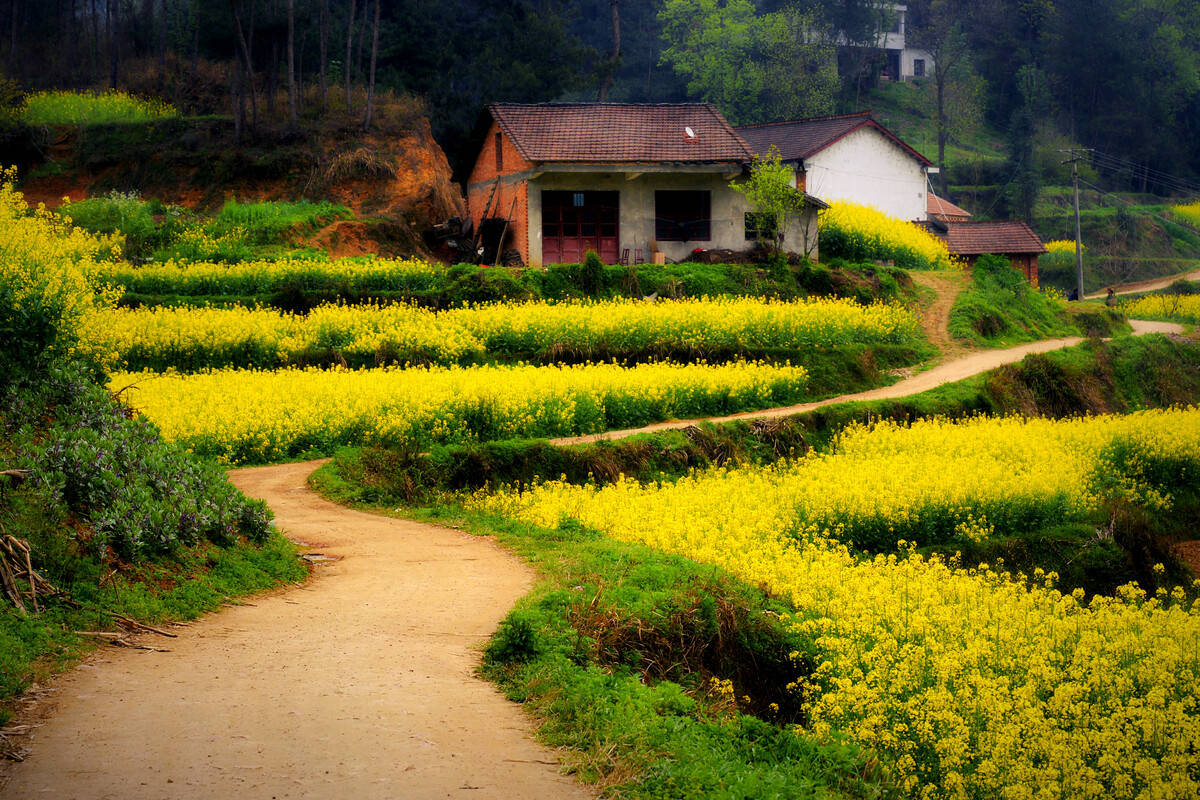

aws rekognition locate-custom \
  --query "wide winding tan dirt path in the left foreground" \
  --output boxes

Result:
[0,463,590,800]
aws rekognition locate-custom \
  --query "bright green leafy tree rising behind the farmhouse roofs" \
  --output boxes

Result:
[659,0,838,125]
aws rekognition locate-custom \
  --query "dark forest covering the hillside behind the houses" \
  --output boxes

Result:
[0,0,1200,194]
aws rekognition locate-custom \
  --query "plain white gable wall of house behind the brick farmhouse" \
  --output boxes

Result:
[804,127,929,221]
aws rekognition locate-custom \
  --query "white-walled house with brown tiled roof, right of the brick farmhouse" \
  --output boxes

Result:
[737,112,936,221]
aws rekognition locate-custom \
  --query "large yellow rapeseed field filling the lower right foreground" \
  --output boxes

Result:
[470,409,1200,800]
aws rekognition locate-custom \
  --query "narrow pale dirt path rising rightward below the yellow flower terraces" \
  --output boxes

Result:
[551,319,1183,445]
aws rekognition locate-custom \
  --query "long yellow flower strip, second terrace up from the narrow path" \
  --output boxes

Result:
[88,297,922,369]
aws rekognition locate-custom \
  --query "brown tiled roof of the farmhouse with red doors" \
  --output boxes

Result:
[488,103,752,163]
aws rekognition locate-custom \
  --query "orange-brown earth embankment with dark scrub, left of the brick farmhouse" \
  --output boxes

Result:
[20,118,466,257]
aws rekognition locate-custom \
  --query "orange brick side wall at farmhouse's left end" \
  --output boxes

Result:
[467,121,534,263]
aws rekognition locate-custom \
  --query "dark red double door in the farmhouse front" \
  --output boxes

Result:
[541,192,620,264]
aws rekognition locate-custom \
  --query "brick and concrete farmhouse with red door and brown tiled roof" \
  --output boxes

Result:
[467,103,823,266]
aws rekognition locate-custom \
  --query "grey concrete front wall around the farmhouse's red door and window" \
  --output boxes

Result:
[526,172,818,266]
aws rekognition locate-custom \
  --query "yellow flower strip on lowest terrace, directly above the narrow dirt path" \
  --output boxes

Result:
[110,362,808,463]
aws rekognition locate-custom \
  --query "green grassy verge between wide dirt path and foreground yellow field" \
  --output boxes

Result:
[312,464,895,799]
